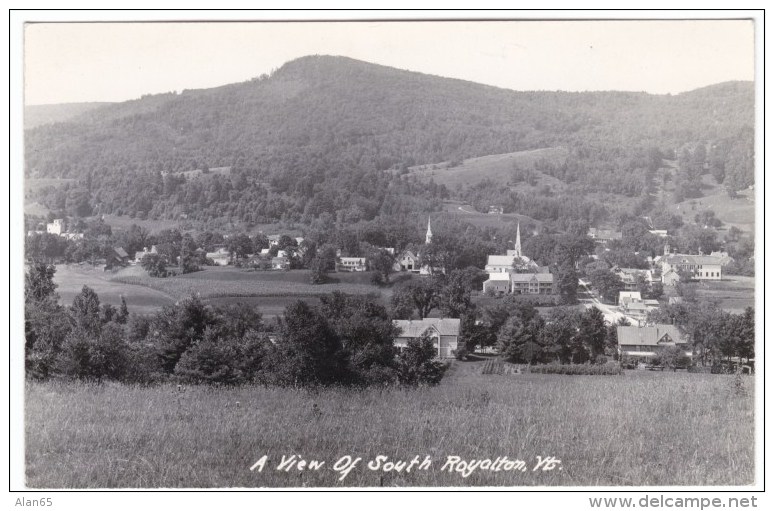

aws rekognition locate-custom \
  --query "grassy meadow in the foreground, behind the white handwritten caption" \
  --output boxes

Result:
[25,362,755,488]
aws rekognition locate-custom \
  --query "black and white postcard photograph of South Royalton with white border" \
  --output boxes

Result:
[9,12,763,500]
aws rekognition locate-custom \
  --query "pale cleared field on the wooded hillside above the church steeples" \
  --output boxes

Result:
[409,147,567,190]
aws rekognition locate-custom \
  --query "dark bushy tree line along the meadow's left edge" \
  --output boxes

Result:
[25,263,446,386]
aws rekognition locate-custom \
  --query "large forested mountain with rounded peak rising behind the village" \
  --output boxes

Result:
[25,56,754,228]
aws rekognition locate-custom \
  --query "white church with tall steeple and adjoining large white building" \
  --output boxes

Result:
[483,225,555,295]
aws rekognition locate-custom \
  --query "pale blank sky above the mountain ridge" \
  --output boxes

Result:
[24,20,755,105]
